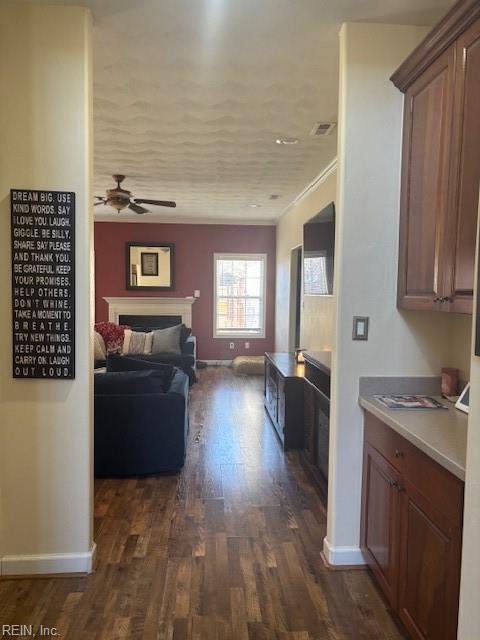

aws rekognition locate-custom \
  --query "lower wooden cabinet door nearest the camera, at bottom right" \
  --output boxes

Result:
[398,482,461,640]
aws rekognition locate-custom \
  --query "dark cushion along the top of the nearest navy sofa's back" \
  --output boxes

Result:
[94,369,165,395]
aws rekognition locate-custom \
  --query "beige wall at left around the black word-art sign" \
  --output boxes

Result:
[0,6,93,574]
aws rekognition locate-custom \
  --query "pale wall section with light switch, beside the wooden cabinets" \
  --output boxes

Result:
[325,24,451,564]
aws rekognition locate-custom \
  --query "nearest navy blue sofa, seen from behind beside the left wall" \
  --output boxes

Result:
[94,369,189,477]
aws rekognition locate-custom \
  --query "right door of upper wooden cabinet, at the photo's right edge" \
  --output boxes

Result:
[450,20,480,313]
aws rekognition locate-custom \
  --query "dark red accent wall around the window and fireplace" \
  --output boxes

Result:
[95,222,276,360]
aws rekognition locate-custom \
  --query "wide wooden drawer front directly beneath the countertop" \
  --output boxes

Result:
[365,412,464,526]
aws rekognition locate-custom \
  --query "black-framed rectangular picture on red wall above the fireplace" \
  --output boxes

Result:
[126,242,175,291]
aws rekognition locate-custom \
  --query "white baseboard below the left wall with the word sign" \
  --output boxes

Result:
[0,543,97,576]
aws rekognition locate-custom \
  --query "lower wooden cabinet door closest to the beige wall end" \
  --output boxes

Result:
[361,443,402,608]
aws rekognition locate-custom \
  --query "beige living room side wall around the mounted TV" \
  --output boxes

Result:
[275,170,337,351]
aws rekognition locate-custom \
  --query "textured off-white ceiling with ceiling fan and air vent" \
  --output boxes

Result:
[27,0,451,222]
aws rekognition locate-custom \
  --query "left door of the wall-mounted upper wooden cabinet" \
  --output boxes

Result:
[398,46,455,310]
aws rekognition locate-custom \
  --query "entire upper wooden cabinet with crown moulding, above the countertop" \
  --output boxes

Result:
[391,0,480,313]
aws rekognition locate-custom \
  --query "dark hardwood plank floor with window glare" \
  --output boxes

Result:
[0,367,404,640]
